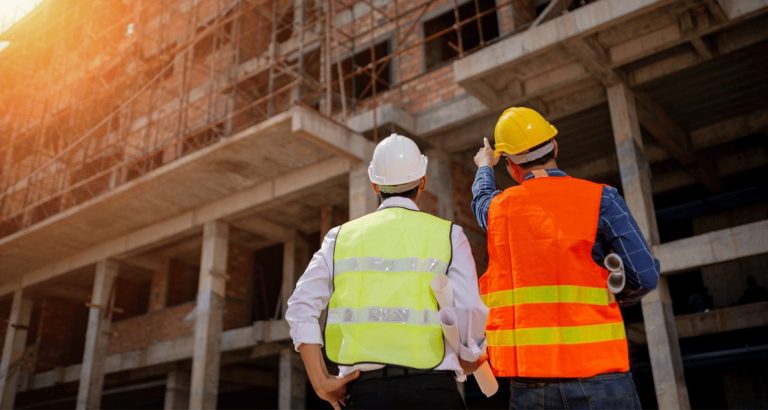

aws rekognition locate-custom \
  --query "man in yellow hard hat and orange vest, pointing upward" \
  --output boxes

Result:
[472,107,659,409]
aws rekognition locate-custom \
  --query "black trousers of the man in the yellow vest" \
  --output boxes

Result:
[346,372,466,410]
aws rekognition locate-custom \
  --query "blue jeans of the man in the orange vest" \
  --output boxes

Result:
[509,372,641,410]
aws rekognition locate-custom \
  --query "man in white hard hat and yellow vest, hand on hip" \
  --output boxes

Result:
[286,134,488,409]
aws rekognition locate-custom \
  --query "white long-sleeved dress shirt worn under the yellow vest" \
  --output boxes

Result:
[285,197,488,381]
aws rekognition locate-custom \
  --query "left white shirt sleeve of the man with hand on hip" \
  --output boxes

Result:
[285,227,339,351]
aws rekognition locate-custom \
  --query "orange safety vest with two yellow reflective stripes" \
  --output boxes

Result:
[480,177,629,378]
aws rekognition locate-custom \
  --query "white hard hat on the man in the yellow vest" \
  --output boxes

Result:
[368,134,427,185]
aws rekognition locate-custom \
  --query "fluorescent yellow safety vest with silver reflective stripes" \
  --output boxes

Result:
[325,208,451,369]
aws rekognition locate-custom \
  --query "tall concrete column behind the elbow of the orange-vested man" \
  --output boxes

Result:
[607,83,690,409]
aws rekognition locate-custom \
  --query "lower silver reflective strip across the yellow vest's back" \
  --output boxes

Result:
[328,307,440,325]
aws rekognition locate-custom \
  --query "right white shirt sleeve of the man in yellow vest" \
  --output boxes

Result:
[448,225,488,362]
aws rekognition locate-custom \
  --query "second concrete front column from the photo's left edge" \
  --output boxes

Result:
[77,259,118,409]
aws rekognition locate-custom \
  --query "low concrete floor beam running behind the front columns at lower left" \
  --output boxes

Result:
[19,320,290,391]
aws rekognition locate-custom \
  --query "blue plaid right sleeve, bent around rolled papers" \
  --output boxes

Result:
[598,186,660,306]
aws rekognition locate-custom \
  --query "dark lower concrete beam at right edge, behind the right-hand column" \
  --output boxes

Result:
[627,302,768,344]
